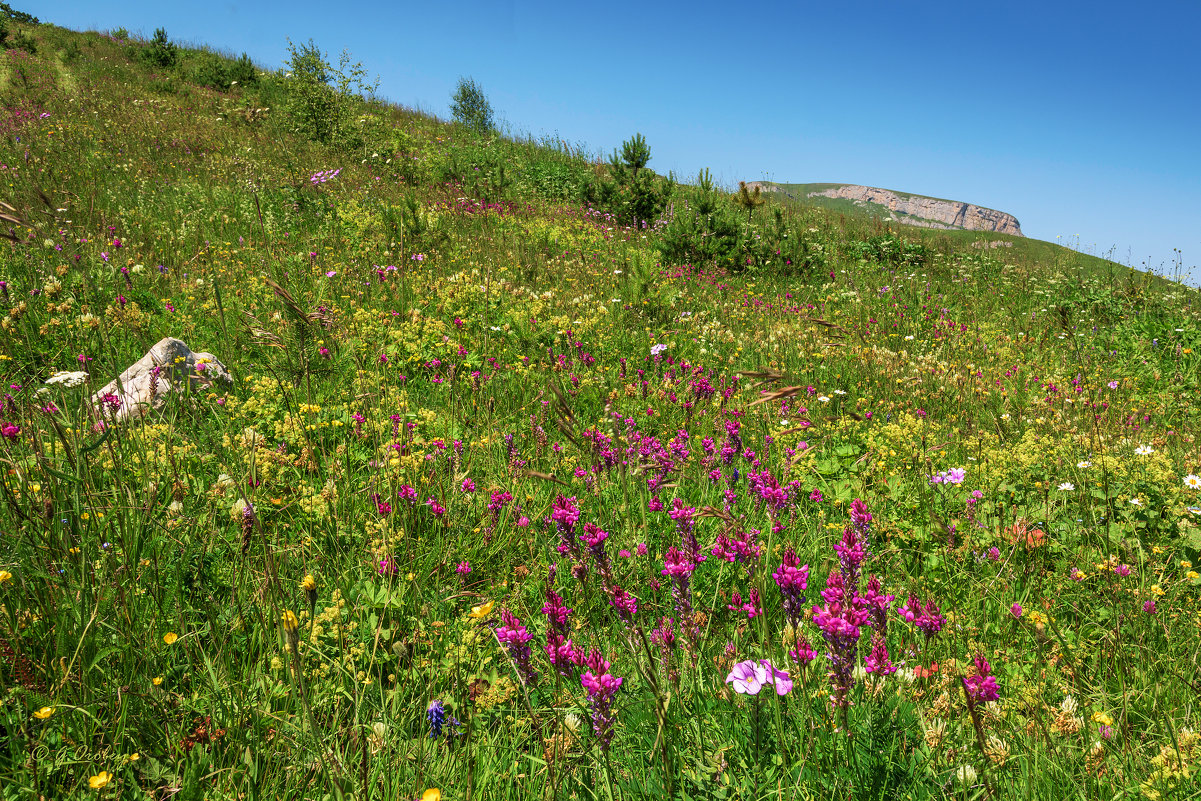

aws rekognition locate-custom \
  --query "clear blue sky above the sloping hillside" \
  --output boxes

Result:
[25,0,1201,285]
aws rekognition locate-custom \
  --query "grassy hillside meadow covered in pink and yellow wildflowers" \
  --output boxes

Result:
[0,20,1201,801]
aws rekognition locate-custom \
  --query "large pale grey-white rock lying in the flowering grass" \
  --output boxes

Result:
[91,336,233,423]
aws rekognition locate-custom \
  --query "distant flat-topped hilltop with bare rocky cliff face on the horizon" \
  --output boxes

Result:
[747,181,1022,237]
